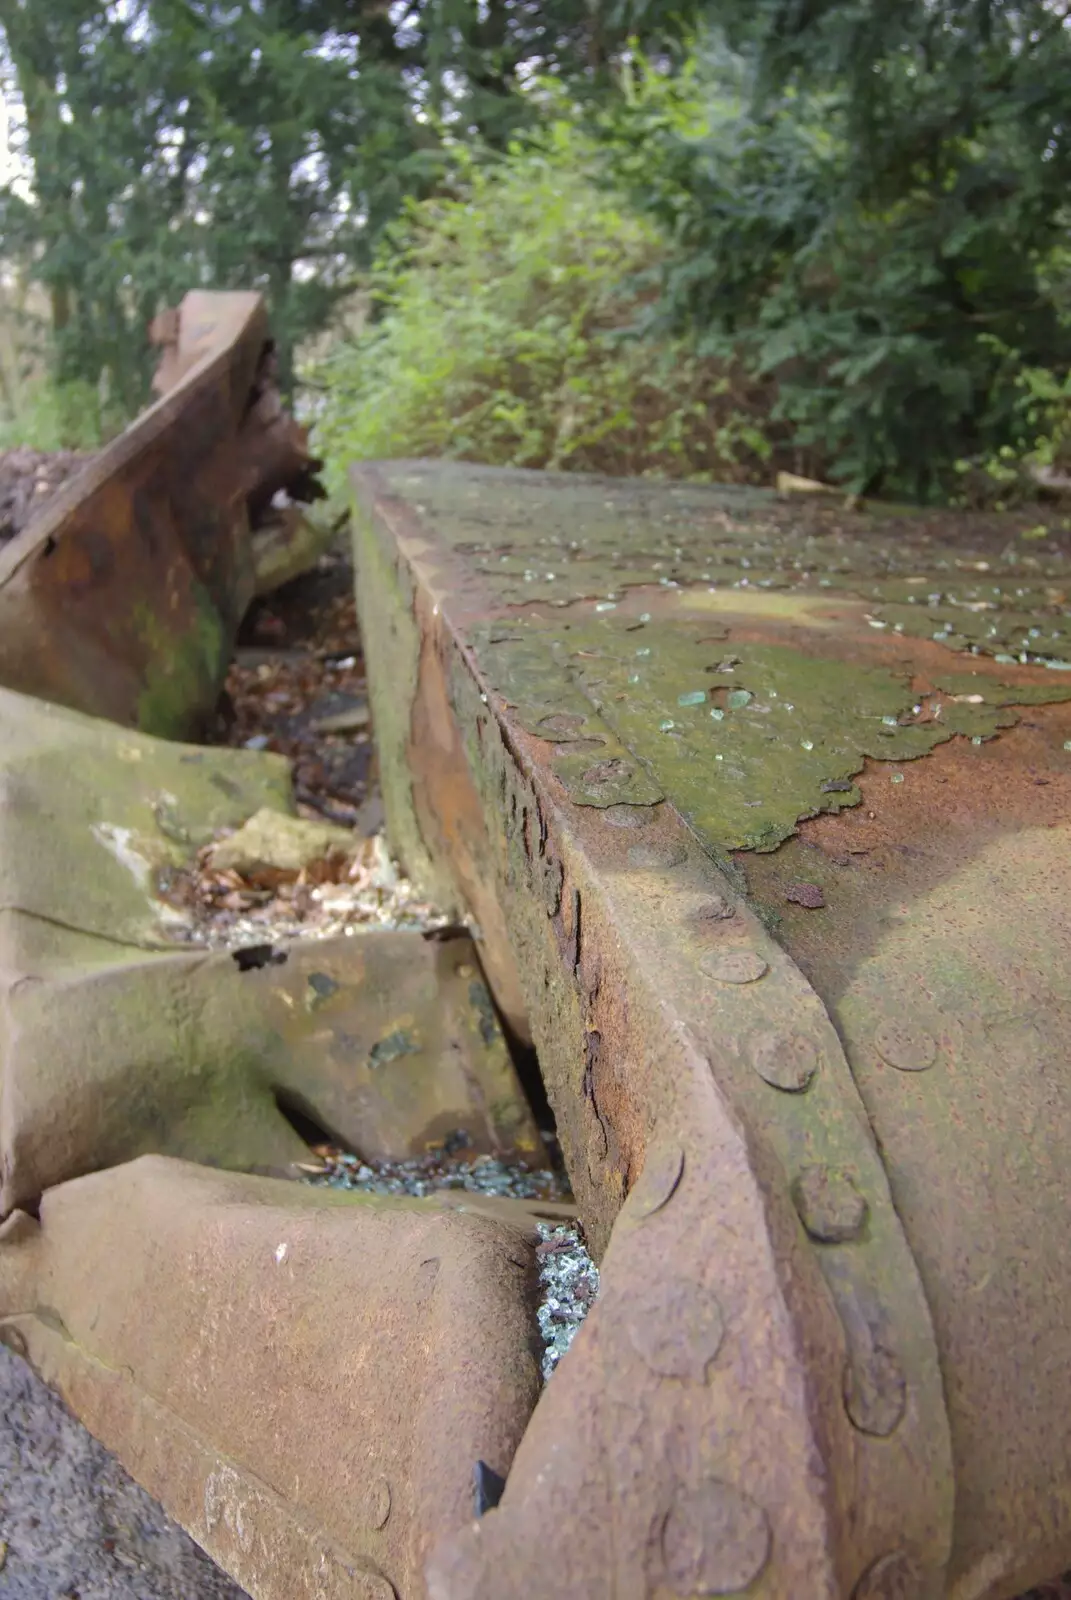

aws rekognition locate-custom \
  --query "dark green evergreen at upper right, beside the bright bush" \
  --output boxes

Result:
[607,14,1071,498]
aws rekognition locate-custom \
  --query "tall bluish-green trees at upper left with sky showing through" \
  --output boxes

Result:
[0,0,697,410]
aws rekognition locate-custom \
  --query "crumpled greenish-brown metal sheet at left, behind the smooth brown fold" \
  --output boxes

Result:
[0,690,541,1213]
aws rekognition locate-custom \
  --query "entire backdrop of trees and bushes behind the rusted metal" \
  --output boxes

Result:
[0,0,1071,499]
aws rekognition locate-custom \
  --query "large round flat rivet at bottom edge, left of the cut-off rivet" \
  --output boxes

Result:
[661,1478,770,1595]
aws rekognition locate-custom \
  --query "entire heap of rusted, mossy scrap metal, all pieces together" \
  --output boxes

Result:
[0,296,1071,1600]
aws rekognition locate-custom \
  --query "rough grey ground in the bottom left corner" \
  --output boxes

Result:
[0,1347,245,1600]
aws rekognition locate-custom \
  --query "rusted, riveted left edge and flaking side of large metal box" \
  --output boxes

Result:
[354,466,953,1600]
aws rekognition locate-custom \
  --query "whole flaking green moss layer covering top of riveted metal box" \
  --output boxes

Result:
[374,462,1071,851]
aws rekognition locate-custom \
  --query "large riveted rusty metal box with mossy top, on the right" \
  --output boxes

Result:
[354,462,1071,1600]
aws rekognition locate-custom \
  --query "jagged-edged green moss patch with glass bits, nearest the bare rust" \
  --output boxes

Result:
[474,606,1069,851]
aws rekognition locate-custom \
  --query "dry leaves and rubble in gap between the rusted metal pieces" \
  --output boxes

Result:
[148,552,448,949]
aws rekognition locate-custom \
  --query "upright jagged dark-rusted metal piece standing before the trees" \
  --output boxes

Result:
[0,291,319,738]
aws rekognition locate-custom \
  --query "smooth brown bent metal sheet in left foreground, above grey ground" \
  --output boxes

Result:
[0,1157,540,1600]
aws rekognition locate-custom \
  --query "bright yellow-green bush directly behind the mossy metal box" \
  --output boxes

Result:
[314,120,770,477]
